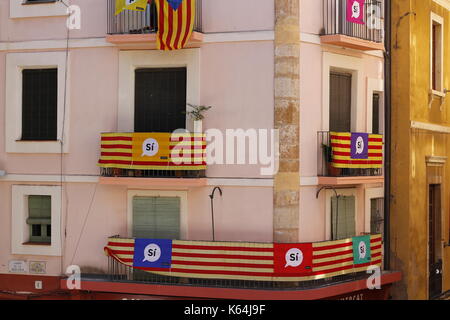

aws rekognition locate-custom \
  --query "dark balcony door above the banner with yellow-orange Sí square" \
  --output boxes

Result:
[134,68,187,132]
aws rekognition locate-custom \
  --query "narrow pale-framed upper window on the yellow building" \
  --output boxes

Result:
[430,13,444,92]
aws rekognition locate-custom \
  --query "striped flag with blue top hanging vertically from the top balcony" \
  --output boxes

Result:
[154,0,195,50]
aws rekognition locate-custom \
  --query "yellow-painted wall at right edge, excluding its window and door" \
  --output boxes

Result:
[390,0,450,299]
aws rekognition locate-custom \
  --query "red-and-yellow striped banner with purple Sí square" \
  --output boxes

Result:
[330,132,383,169]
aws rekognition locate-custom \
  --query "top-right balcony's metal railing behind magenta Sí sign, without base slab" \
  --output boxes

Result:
[323,0,384,43]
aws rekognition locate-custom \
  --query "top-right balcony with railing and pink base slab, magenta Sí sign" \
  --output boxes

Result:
[321,0,384,51]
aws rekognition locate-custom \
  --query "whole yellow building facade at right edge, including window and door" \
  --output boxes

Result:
[390,0,450,299]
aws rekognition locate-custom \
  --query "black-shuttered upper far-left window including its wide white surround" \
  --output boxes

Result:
[5,51,71,154]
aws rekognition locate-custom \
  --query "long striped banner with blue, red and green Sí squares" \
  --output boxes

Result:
[104,234,382,282]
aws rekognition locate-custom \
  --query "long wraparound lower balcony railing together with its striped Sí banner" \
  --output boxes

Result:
[105,234,383,289]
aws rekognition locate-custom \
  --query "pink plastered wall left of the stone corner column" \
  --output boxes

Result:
[0,0,274,276]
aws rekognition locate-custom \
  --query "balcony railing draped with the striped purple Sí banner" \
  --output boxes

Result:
[317,131,383,177]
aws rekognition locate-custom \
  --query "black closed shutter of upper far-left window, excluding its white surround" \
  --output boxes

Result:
[22,69,58,140]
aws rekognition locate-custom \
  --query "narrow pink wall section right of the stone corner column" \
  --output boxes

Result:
[299,0,384,242]
